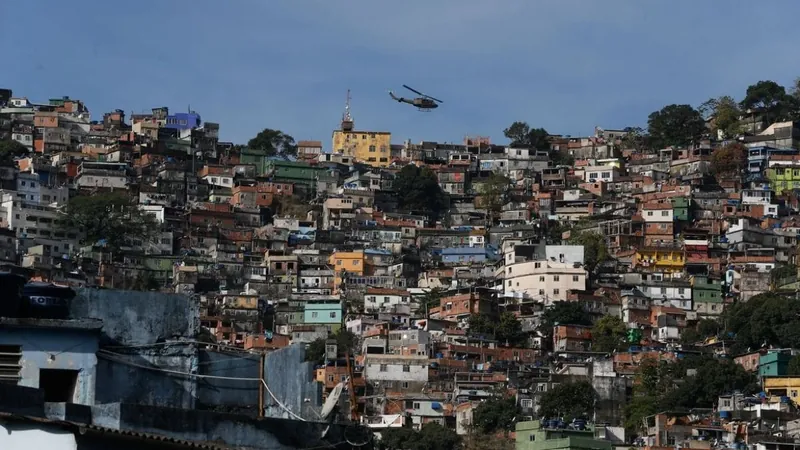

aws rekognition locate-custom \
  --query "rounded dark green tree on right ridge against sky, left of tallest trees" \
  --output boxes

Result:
[647,105,706,148]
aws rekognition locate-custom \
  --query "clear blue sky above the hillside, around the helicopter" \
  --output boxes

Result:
[0,0,800,149]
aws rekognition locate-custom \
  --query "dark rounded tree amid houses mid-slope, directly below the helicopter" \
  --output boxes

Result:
[392,164,447,220]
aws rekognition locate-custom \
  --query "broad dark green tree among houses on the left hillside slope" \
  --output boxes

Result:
[62,191,160,252]
